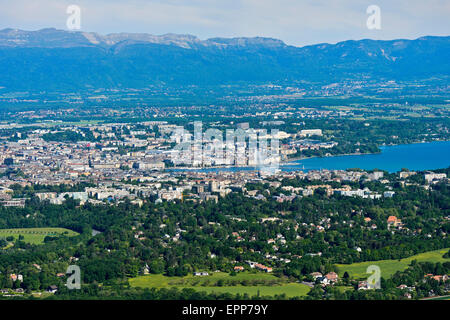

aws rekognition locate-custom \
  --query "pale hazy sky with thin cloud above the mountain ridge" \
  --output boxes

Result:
[0,0,450,46]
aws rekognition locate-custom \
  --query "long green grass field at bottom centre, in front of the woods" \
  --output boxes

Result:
[129,272,310,297]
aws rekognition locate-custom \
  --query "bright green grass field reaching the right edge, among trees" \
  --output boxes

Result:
[336,248,450,279]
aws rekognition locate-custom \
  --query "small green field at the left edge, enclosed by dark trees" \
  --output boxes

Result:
[0,228,78,244]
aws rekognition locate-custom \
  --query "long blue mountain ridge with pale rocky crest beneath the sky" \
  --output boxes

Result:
[0,29,450,91]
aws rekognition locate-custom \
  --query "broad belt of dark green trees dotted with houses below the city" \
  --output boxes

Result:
[0,174,450,297]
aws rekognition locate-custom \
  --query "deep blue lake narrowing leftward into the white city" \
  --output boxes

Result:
[172,141,450,172]
